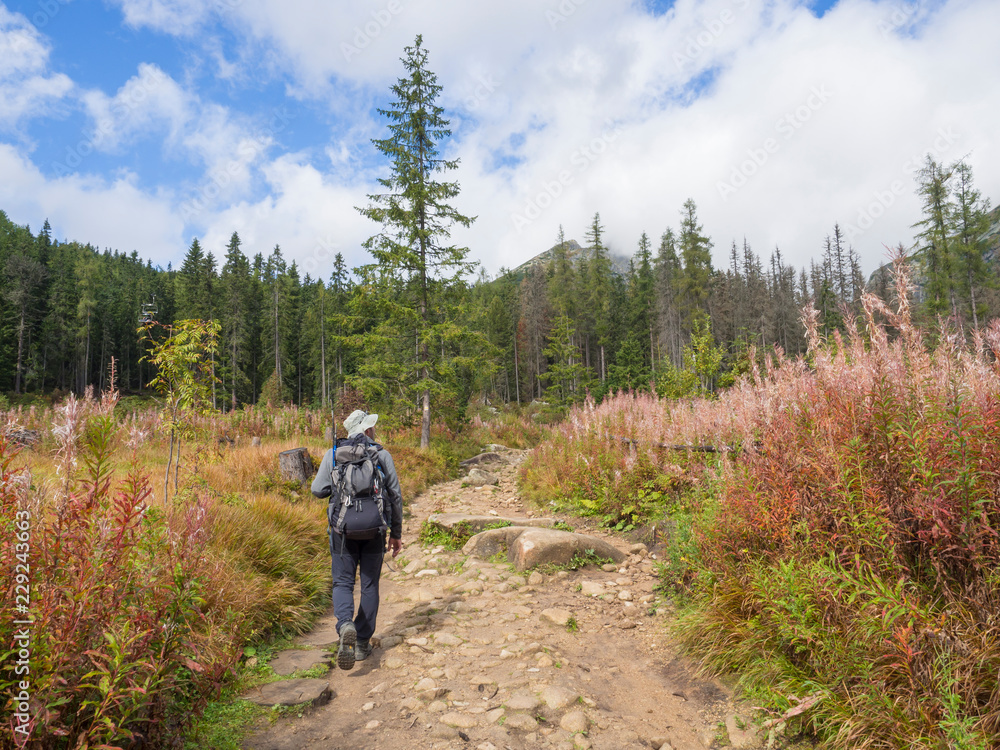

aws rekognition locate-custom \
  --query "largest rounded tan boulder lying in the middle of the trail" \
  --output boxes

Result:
[462,526,625,571]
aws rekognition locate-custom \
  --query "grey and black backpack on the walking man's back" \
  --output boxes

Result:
[327,435,388,540]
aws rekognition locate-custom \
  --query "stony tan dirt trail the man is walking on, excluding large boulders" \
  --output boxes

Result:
[243,446,762,750]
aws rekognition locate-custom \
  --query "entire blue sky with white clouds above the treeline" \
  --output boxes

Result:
[0,0,1000,278]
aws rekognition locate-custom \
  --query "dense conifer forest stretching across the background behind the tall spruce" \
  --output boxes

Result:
[0,158,998,419]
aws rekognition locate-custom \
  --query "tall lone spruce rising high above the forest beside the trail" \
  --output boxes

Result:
[358,34,476,448]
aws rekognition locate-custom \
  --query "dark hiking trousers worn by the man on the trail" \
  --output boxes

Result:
[330,531,385,641]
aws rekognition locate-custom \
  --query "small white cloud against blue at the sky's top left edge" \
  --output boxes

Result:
[0,4,73,128]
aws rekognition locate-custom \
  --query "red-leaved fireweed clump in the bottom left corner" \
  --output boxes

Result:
[0,414,232,748]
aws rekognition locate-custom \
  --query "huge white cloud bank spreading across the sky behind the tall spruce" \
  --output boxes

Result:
[1,0,1000,284]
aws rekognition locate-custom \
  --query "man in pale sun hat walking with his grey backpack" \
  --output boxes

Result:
[312,409,403,669]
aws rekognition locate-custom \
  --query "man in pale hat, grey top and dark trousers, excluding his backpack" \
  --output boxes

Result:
[312,409,403,669]
